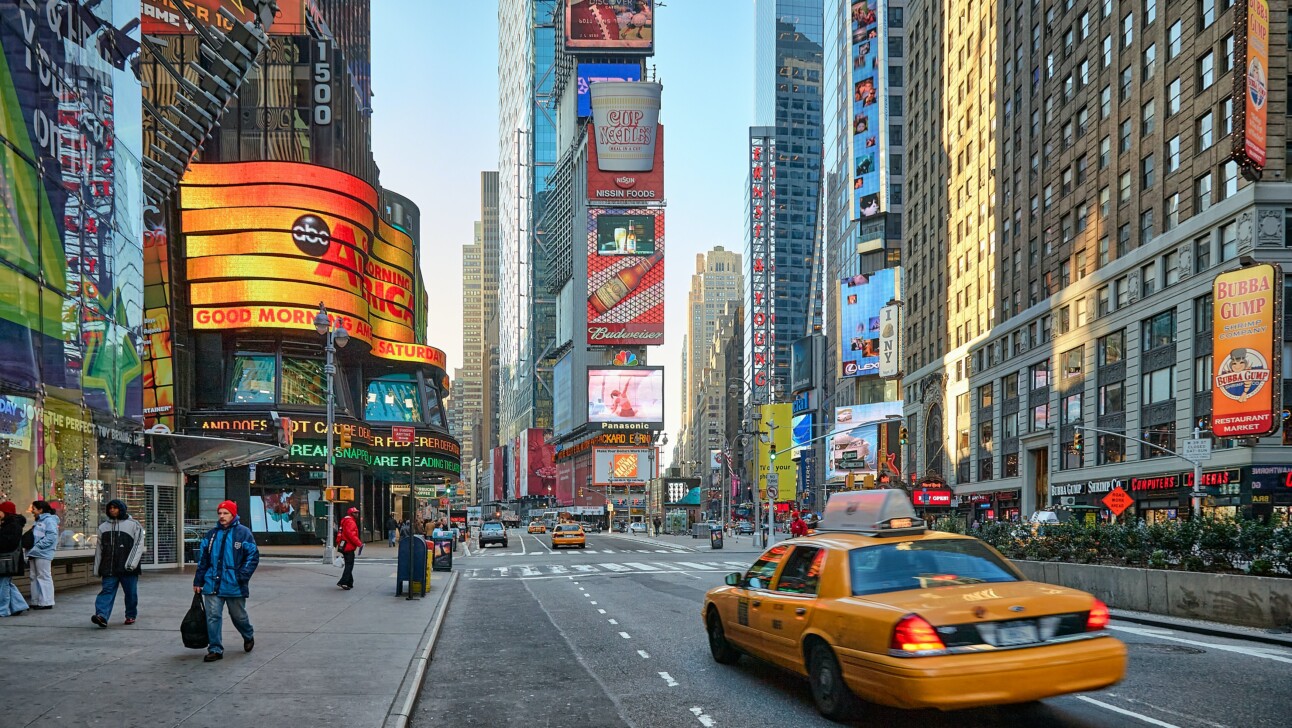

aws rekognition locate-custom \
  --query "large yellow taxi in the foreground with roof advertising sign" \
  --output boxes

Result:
[702,490,1127,719]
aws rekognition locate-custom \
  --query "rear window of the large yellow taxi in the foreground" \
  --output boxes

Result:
[848,538,1022,596]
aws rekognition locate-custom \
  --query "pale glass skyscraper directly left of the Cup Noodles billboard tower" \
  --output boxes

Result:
[496,0,558,442]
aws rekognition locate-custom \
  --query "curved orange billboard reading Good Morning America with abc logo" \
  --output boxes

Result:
[180,162,446,369]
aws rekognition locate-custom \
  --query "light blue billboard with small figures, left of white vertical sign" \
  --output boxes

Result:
[839,268,898,376]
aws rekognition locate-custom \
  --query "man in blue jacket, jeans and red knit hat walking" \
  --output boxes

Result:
[193,500,260,662]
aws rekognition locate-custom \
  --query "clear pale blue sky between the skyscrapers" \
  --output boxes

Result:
[372,0,753,450]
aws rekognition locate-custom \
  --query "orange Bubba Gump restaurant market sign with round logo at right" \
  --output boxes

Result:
[1211,262,1283,437]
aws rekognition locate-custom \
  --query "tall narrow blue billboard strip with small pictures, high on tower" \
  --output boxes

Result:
[850,0,881,220]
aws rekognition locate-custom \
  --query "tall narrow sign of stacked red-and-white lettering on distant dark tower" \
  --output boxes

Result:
[745,127,776,402]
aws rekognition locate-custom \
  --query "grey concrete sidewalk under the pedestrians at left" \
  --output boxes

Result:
[0,550,456,728]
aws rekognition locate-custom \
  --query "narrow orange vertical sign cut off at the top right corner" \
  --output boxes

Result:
[1234,0,1270,173]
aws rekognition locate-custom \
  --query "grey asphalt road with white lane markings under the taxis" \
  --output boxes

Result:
[412,531,1292,728]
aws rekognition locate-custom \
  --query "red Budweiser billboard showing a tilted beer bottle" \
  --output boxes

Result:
[588,208,664,347]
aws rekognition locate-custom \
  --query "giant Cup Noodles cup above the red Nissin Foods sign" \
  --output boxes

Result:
[588,81,664,172]
